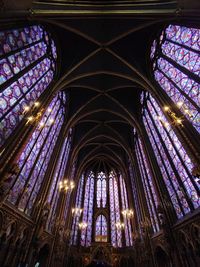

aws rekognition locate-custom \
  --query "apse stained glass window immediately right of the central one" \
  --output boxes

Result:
[109,171,122,247]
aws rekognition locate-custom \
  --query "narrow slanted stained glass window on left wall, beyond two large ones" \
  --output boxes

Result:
[47,131,71,231]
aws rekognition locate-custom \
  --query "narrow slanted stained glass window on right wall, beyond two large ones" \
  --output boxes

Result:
[135,136,159,232]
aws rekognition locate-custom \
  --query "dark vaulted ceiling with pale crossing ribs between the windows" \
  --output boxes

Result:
[40,18,167,178]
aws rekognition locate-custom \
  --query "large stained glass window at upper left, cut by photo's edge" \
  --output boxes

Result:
[0,25,57,146]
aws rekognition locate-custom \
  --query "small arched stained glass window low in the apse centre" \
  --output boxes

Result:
[95,214,107,242]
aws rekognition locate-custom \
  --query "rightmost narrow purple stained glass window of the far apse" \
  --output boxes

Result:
[119,174,133,246]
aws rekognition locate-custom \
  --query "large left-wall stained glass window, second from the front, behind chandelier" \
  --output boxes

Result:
[8,92,66,214]
